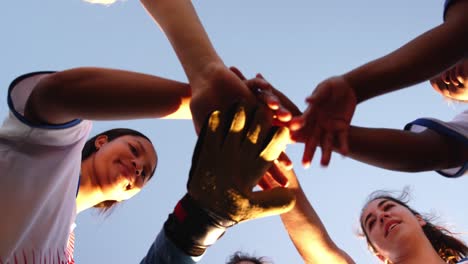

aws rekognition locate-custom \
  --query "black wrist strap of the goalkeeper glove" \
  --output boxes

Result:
[164,194,236,256]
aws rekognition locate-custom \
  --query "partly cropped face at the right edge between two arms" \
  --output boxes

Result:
[431,59,468,102]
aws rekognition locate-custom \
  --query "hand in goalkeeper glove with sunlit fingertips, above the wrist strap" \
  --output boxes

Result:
[187,102,295,222]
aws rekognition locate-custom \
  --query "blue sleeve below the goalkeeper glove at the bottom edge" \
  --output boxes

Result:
[140,229,201,264]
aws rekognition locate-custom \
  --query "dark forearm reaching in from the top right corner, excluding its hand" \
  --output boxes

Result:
[344,1,468,102]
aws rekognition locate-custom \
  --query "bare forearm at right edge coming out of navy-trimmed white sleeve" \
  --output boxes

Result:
[342,127,467,172]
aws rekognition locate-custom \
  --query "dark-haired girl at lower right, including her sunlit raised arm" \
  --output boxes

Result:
[274,167,468,264]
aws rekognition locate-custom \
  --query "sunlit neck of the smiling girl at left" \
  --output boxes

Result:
[76,156,106,213]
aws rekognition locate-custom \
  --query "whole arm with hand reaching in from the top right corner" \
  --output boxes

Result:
[290,0,468,165]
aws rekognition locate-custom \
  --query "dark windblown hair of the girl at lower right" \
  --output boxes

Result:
[361,187,468,264]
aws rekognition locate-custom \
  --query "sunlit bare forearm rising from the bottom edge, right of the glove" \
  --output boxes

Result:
[281,170,354,264]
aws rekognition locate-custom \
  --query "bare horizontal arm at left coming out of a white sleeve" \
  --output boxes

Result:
[25,68,191,124]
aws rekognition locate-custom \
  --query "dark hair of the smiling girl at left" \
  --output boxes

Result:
[81,128,154,213]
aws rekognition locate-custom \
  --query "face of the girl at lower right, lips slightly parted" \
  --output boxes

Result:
[360,199,426,259]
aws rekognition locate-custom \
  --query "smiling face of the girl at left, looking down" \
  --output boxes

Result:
[93,135,157,201]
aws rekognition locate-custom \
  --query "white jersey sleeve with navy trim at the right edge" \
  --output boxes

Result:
[405,110,468,177]
